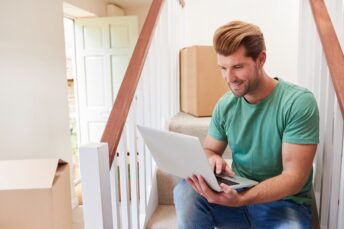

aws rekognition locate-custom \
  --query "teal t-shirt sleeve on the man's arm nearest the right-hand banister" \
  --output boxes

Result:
[283,92,319,144]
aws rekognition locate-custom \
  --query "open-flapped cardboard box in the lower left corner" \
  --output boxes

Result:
[0,159,72,229]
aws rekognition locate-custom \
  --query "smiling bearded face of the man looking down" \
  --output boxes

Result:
[217,46,261,97]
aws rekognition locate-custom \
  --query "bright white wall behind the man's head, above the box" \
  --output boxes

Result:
[185,0,299,82]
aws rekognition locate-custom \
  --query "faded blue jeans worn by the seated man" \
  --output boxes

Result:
[173,180,311,229]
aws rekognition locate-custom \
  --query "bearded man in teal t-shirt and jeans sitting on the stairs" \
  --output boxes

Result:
[174,21,319,229]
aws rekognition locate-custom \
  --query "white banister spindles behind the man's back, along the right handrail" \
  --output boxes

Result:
[298,0,344,229]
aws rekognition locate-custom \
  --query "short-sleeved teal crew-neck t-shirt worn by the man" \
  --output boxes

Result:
[208,79,319,203]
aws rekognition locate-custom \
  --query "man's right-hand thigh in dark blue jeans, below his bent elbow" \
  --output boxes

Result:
[247,200,312,229]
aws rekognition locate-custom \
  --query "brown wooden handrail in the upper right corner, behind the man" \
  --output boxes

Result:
[310,0,344,118]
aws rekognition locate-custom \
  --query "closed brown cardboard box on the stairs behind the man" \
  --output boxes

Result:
[180,46,229,117]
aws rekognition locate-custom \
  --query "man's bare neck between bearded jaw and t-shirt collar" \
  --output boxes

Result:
[244,72,278,104]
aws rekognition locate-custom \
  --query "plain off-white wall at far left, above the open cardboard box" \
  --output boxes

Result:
[0,0,71,162]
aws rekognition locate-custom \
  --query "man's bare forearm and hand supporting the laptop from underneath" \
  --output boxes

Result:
[192,139,317,206]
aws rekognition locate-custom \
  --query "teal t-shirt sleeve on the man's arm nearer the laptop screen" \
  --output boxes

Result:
[208,100,227,142]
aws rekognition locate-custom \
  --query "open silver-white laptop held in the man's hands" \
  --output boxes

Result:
[137,125,258,192]
